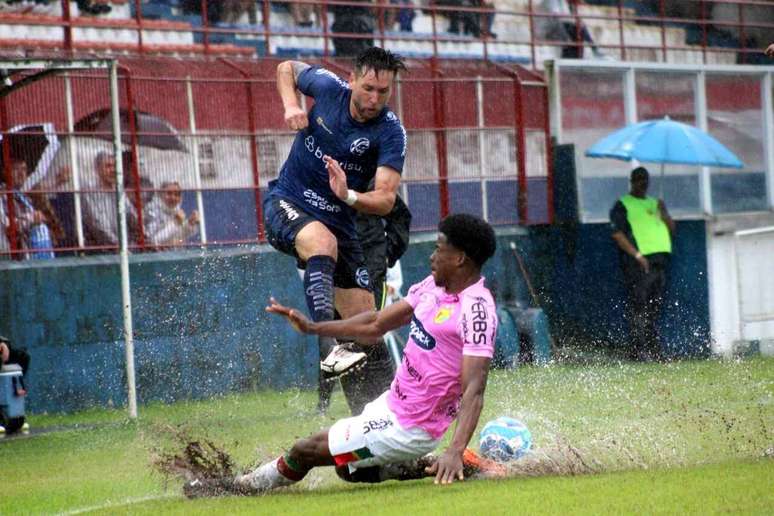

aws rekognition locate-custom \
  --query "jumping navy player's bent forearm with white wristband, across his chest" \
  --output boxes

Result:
[323,156,400,215]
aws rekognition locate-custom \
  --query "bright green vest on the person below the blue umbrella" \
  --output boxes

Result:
[621,194,672,255]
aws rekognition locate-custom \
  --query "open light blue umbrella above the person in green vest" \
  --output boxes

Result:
[586,117,744,170]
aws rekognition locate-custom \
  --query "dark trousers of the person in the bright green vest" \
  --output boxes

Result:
[623,253,670,360]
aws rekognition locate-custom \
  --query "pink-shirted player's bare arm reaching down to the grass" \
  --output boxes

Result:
[427,356,491,484]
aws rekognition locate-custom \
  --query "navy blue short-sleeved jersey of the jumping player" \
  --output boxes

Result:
[271,66,406,237]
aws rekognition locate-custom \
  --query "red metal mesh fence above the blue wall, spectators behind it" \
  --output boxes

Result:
[0,56,552,258]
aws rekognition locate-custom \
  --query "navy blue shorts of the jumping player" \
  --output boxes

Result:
[263,195,372,292]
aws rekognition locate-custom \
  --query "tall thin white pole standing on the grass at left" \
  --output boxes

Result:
[110,61,137,419]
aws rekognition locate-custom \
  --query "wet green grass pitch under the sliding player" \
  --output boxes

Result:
[0,358,774,514]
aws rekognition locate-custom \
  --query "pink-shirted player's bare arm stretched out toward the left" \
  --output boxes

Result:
[266,297,414,344]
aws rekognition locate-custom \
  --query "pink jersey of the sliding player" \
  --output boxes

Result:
[387,275,497,439]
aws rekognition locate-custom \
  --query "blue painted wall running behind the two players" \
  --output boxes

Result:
[0,222,709,412]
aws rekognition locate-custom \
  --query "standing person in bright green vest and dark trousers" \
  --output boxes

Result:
[610,167,675,360]
